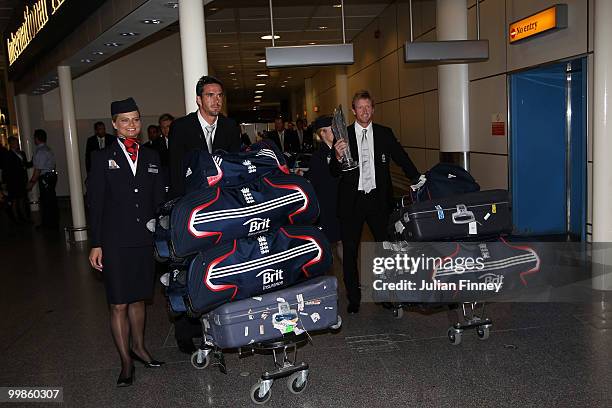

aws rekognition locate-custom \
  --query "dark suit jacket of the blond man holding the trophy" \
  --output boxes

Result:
[329,123,420,218]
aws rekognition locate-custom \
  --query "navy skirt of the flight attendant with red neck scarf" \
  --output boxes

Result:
[102,246,155,304]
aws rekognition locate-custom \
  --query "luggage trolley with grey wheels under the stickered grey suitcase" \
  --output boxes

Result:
[191,322,342,405]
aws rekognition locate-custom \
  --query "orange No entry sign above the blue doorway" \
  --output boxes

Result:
[508,4,567,44]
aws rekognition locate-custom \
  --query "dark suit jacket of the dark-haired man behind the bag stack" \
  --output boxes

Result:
[168,111,240,199]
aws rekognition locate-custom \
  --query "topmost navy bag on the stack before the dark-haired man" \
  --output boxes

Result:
[184,143,289,193]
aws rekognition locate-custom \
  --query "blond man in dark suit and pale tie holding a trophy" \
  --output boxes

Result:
[329,91,420,313]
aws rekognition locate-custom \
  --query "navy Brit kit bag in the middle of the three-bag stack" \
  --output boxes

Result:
[169,174,319,257]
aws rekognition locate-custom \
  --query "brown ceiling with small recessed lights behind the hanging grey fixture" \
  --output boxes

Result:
[201,0,391,111]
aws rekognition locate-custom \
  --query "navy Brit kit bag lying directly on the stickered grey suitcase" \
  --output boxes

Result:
[167,226,333,313]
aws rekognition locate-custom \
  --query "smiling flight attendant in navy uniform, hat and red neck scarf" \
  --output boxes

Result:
[87,98,164,387]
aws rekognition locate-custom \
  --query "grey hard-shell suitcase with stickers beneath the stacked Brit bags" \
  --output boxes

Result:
[202,276,340,349]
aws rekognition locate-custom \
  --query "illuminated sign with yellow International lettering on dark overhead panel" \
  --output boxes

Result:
[6,0,65,66]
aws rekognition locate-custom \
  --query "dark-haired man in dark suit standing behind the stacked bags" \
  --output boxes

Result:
[169,76,240,198]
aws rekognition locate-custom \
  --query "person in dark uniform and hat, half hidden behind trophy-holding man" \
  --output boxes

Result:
[298,116,342,262]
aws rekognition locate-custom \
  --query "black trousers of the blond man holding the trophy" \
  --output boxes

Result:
[340,190,389,305]
